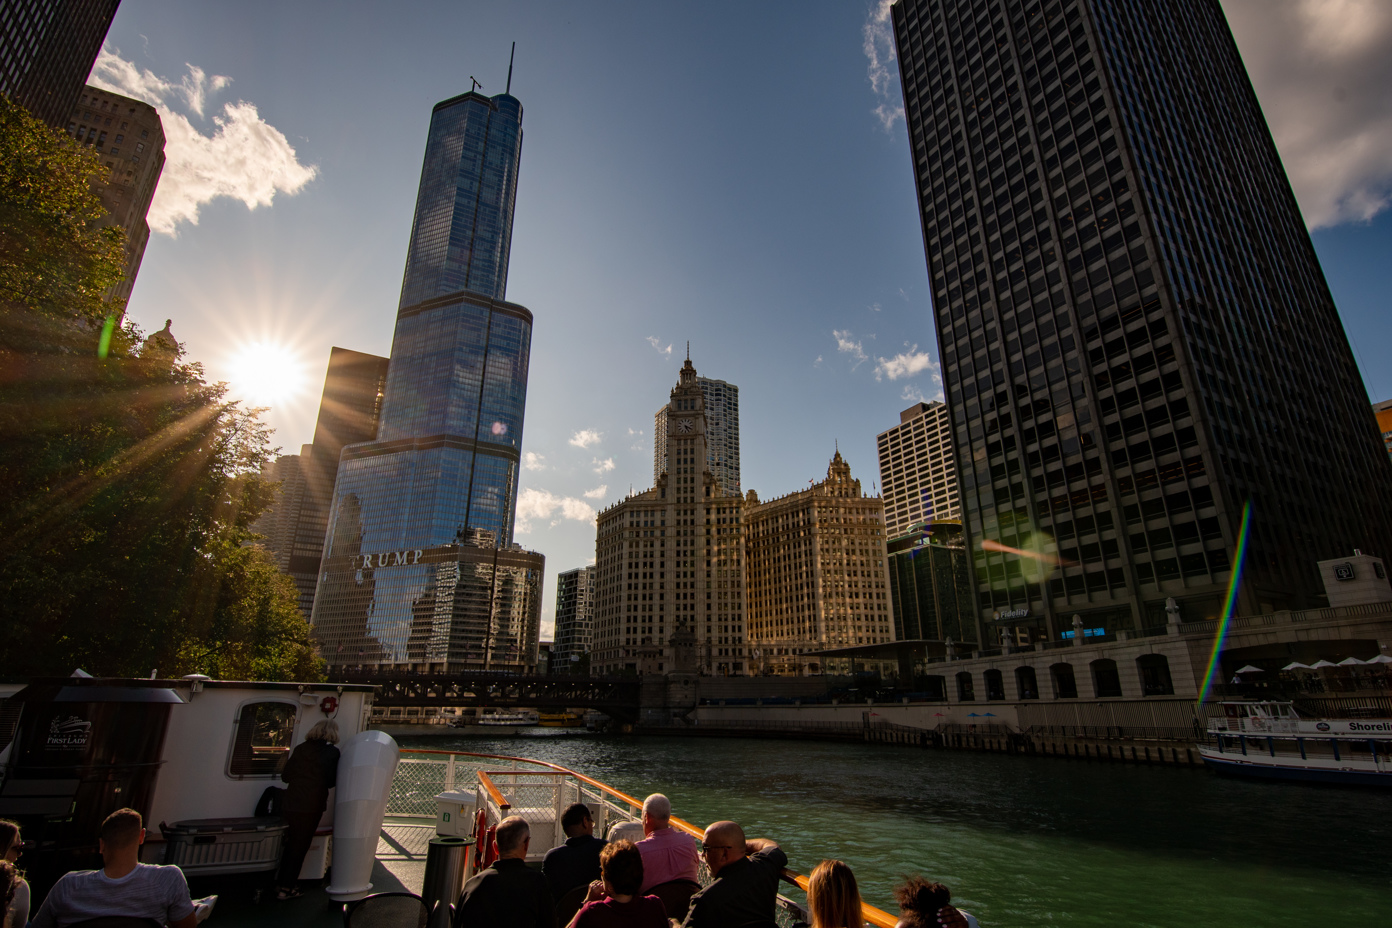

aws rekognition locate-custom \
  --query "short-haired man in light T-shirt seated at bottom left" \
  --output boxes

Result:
[29,808,198,928]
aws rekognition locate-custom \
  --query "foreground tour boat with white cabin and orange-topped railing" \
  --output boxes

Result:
[0,676,895,928]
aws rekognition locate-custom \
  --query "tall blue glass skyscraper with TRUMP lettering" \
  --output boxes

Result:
[313,92,540,666]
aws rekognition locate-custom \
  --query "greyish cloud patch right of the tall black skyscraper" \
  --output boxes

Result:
[1222,0,1392,228]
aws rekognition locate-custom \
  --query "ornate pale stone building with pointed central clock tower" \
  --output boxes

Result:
[590,358,749,675]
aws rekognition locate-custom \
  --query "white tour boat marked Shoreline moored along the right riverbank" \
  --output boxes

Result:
[1199,700,1392,786]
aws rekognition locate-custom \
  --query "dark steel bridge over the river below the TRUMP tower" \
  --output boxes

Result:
[336,672,643,722]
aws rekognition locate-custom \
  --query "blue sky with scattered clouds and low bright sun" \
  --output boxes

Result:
[92,0,1392,639]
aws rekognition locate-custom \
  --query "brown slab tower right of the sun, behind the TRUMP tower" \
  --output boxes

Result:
[285,348,387,619]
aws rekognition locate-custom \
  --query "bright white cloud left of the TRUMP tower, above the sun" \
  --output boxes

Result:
[89,47,319,235]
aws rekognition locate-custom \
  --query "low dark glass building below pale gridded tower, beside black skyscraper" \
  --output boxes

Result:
[888,520,974,648]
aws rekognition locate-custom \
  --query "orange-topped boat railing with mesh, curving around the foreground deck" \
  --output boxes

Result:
[387,749,898,928]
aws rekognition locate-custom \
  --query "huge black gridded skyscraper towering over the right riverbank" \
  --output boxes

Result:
[892,0,1392,640]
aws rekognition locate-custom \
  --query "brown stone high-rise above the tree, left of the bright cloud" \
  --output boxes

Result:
[67,86,164,302]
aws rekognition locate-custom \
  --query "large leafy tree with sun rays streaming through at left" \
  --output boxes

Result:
[0,102,322,679]
